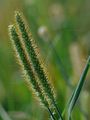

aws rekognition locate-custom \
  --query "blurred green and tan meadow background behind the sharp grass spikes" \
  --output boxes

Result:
[0,0,90,120]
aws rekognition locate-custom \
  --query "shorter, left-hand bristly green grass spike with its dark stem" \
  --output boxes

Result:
[9,25,56,120]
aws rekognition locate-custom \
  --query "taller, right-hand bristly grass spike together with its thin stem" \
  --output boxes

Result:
[15,12,63,120]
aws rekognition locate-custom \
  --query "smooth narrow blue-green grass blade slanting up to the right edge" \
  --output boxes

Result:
[68,56,90,120]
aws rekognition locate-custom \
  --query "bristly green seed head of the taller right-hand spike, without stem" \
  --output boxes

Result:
[15,11,54,99]
